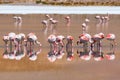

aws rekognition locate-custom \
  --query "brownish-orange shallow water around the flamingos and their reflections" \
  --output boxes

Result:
[0,14,120,80]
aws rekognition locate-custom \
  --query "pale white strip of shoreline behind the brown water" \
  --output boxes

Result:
[0,5,120,14]
